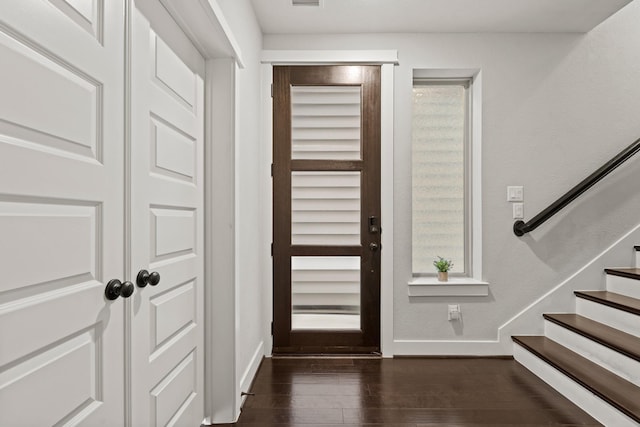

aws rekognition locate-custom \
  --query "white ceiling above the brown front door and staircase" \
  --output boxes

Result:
[251,0,640,34]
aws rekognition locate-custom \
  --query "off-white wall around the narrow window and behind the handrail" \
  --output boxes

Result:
[263,1,640,353]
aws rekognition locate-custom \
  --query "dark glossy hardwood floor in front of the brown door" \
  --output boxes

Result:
[219,358,601,427]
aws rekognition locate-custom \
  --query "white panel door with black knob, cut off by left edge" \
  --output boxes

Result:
[0,0,125,427]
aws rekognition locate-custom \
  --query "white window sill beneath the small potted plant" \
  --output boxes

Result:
[408,277,489,297]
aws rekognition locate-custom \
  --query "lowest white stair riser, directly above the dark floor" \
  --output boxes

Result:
[513,344,638,427]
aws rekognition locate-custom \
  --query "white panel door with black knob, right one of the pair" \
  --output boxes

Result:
[131,1,205,427]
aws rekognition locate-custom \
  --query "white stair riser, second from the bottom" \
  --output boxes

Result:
[544,320,640,387]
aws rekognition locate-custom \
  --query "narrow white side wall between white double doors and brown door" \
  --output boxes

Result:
[214,0,265,398]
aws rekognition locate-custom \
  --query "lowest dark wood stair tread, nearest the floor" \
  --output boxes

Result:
[512,336,640,422]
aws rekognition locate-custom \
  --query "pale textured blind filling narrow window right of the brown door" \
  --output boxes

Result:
[412,80,469,274]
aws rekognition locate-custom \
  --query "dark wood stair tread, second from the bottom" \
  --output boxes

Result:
[544,313,640,362]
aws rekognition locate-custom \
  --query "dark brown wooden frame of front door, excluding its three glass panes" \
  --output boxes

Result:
[273,65,381,354]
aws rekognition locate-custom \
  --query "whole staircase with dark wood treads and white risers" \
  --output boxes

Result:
[512,246,640,427]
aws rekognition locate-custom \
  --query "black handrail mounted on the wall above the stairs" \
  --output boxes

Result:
[513,139,640,236]
